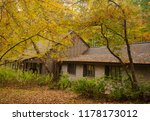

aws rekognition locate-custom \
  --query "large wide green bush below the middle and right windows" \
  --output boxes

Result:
[72,78,144,101]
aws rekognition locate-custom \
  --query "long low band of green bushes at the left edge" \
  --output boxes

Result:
[0,67,52,87]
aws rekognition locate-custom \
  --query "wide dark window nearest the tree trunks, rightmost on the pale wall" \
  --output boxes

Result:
[105,66,121,79]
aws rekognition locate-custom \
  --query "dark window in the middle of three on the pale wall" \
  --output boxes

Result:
[83,65,95,77]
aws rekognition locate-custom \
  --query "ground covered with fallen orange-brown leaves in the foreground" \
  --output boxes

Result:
[0,87,144,104]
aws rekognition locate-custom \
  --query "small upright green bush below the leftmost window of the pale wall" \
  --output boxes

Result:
[58,74,71,89]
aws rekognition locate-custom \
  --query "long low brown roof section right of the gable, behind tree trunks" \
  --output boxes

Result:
[62,43,150,64]
